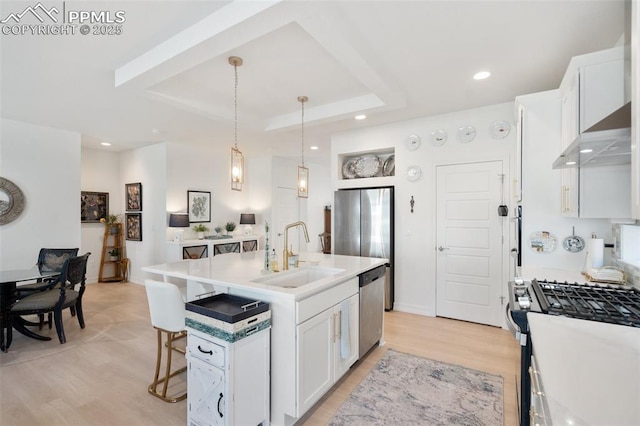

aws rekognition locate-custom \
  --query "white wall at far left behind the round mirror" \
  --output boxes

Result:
[0,118,81,269]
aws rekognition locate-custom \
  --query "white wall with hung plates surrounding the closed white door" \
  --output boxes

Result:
[331,102,516,316]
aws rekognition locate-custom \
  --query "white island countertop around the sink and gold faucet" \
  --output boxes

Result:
[142,250,387,300]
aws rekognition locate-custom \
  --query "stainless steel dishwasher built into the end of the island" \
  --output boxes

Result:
[358,265,387,358]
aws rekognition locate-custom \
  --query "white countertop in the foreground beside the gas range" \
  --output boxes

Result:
[527,313,640,426]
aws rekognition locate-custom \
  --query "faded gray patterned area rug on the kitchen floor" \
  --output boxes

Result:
[329,349,503,426]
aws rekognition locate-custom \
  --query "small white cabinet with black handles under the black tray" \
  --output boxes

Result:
[187,327,270,426]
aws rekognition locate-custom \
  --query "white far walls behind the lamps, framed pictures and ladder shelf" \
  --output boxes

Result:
[82,142,331,283]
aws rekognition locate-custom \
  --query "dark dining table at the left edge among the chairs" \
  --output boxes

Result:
[0,265,60,352]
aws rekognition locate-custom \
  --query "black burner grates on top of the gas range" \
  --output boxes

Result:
[532,280,640,327]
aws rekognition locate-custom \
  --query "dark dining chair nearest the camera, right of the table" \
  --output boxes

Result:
[11,253,91,343]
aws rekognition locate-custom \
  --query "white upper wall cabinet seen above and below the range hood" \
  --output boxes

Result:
[560,47,629,218]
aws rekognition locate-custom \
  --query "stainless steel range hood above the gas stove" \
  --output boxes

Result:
[553,102,631,169]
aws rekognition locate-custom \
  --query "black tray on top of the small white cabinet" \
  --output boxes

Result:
[186,293,269,323]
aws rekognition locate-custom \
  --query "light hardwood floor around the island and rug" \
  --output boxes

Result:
[0,283,519,426]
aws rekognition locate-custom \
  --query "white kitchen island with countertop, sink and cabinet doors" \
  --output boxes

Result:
[142,250,387,425]
